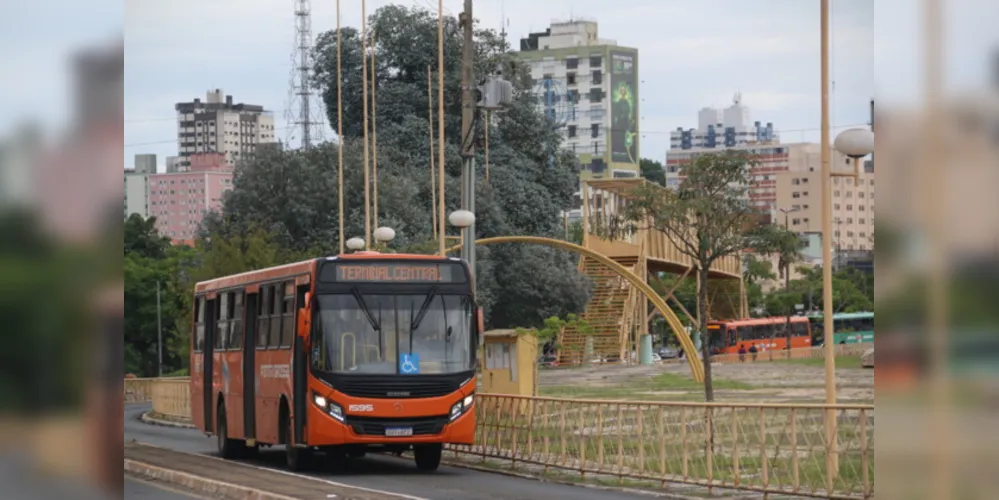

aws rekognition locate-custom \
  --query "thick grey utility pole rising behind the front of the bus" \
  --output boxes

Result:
[460,0,476,276]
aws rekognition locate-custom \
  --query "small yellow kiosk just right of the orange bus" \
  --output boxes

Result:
[479,330,538,396]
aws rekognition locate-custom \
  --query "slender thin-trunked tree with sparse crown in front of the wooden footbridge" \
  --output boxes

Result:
[627,151,759,401]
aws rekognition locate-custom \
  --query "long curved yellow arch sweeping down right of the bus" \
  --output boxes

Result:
[447,236,704,382]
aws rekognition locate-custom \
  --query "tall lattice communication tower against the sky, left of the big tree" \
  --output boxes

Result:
[284,0,325,149]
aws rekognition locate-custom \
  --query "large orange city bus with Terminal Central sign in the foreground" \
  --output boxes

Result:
[190,252,482,470]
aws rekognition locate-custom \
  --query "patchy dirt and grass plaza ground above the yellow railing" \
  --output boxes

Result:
[539,361,874,404]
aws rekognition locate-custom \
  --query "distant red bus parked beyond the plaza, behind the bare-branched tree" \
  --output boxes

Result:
[708,316,812,354]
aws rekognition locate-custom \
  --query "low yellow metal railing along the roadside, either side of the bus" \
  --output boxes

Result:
[125,378,874,499]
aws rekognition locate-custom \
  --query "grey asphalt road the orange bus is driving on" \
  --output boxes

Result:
[125,404,653,500]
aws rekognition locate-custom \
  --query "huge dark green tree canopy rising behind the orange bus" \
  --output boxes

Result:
[199,5,587,328]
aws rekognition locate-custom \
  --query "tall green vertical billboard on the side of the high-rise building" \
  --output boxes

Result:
[610,50,638,164]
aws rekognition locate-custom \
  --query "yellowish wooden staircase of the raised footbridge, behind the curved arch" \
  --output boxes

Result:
[558,256,645,365]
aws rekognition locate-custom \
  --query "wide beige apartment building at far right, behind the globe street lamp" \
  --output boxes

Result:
[774,144,874,251]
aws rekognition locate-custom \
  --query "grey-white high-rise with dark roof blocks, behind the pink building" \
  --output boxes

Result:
[175,89,277,171]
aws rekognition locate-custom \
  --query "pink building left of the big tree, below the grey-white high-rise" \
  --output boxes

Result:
[148,153,232,243]
